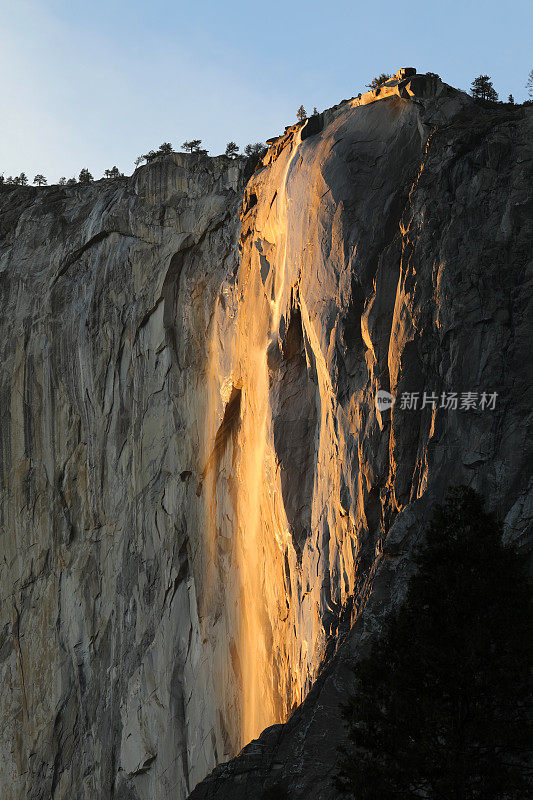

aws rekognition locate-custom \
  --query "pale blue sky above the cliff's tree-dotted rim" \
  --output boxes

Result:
[0,0,533,182]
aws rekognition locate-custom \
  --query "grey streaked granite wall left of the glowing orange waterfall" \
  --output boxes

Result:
[0,156,244,798]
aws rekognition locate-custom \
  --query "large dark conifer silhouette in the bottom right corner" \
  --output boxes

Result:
[337,488,533,800]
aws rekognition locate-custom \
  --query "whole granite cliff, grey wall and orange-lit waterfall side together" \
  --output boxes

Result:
[0,76,533,800]
